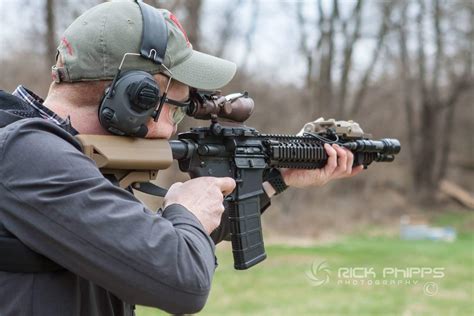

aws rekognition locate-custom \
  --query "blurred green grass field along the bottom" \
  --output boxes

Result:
[137,213,474,316]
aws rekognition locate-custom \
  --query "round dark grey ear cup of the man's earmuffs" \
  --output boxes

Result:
[99,71,160,137]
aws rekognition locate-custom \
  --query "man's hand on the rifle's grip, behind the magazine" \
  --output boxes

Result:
[163,177,235,234]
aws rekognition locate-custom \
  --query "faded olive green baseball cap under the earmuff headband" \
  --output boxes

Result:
[52,1,236,90]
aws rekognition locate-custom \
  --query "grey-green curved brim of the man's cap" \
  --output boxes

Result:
[170,50,237,90]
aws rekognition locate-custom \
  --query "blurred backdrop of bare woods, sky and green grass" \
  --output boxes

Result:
[0,0,474,315]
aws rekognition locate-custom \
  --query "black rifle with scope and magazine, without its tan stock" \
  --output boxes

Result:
[170,93,400,270]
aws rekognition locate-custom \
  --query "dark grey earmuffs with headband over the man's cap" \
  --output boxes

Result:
[99,1,168,137]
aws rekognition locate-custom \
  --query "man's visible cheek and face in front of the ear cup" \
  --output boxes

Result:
[145,76,189,139]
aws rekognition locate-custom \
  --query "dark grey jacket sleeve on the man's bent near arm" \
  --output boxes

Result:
[0,119,216,314]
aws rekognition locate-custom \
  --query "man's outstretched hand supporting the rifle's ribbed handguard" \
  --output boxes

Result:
[281,144,363,188]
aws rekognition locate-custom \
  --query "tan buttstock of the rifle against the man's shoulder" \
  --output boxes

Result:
[76,135,173,188]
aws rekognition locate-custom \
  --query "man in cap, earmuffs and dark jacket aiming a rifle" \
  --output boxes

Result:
[0,1,374,315]
